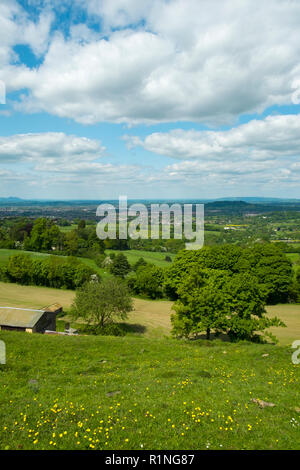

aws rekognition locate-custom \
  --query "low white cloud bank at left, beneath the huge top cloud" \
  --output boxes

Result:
[0,132,141,186]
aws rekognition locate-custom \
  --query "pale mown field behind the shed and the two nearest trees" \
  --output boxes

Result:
[0,282,300,345]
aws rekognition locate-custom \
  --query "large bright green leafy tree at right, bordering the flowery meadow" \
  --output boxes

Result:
[171,267,285,340]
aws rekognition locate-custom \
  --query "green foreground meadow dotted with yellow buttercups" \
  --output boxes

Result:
[0,332,300,449]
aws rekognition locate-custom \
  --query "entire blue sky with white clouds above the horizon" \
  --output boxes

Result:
[0,0,300,200]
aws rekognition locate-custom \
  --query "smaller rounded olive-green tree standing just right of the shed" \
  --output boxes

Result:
[72,278,133,327]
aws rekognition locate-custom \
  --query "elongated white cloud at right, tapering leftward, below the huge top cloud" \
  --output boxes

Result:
[128,114,300,164]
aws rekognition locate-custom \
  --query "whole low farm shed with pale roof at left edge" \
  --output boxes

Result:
[0,304,62,333]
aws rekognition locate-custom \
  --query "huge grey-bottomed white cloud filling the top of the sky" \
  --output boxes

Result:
[0,0,300,125]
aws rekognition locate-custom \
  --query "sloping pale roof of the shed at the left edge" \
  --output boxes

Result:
[0,307,45,328]
